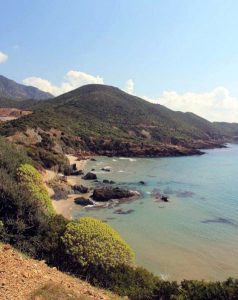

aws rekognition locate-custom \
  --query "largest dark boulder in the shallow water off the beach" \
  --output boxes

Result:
[92,186,135,201]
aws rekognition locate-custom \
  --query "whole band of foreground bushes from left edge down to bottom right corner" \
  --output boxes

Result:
[0,115,238,300]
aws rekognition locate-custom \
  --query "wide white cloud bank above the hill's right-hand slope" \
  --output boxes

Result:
[143,86,238,122]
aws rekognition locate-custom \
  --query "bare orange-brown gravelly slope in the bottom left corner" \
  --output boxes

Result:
[0,245,120,300]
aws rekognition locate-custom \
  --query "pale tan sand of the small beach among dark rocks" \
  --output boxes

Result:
[43,155,87,219]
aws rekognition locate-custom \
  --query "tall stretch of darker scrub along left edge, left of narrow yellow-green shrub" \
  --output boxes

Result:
[0,138,48,255]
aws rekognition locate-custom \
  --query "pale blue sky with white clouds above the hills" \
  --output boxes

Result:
[0,0,238,122]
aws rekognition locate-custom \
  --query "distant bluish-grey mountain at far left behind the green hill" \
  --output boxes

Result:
[0,75,53,100]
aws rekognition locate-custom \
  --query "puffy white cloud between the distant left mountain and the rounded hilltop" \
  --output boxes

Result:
[23,70,104,96]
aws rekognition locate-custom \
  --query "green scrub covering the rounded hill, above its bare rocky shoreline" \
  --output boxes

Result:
[2,85,226,143]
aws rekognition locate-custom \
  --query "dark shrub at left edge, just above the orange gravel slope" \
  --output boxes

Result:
[0,169,47,256]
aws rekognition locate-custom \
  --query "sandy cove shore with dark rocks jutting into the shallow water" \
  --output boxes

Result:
[44,155,140,219]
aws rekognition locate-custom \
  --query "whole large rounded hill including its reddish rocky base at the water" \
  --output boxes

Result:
[0,84,228,168]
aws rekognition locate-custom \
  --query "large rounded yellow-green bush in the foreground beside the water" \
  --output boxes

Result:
[62,217,134,269]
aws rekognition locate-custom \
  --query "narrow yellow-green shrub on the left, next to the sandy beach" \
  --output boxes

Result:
[17,164,55,215]
